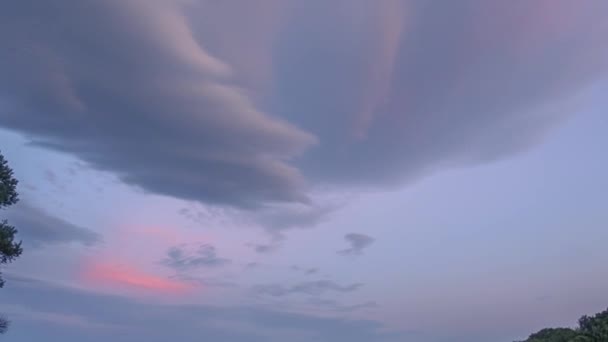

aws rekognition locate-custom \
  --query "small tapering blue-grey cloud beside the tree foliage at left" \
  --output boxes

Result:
[6,200,102,246]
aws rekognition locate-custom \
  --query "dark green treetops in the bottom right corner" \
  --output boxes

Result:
[522,309,608,342]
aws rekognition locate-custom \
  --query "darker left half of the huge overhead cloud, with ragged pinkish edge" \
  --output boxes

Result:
[0,0,316,206]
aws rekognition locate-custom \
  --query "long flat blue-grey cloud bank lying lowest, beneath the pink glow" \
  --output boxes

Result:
[3,278,403,342]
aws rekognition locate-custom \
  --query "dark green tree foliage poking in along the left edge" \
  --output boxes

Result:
[0,153,23,334]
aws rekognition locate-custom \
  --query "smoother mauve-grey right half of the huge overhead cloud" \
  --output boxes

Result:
[275,0,608,188]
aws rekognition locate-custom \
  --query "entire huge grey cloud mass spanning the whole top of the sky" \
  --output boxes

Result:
[0,0,608,208]
